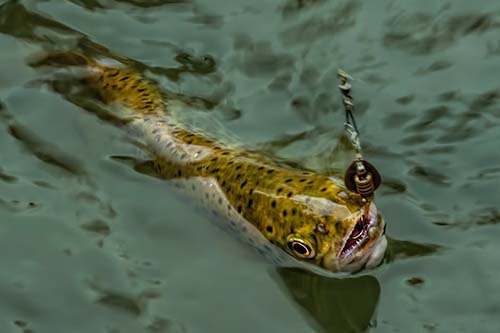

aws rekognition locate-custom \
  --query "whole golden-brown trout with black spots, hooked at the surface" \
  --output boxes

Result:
[33,51,387,273]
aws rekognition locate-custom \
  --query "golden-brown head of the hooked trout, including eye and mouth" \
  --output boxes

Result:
[270,176,387,272]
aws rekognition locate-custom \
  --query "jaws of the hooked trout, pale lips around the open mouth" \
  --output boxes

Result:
[322,203,387,272]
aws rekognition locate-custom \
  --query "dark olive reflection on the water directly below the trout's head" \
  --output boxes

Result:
[273,268,380,333]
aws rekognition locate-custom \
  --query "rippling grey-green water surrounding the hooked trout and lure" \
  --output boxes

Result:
[0,0,500,333]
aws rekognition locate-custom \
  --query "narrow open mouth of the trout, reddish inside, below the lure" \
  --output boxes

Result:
[339,204,383,260]
